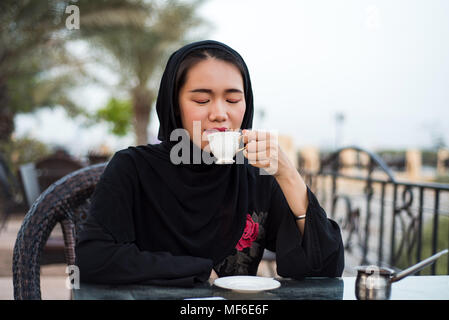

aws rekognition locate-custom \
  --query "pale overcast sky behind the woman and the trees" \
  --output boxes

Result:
[16,0,449,154]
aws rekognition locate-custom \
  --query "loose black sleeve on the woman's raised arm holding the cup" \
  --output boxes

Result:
[266,180,344,279]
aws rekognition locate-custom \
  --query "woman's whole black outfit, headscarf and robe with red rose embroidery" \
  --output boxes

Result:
[75,41,344,286]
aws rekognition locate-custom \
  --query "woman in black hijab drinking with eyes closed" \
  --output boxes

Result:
[76,41,344,286]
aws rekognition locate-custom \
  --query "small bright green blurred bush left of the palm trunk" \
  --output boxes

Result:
[95,98,133,136]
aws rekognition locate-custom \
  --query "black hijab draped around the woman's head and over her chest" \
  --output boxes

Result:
[106,40,254,263]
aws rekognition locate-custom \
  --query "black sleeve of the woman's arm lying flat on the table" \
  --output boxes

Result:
[75,153,212,286]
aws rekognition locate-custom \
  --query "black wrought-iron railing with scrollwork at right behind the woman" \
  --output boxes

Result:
[300,146,449,274]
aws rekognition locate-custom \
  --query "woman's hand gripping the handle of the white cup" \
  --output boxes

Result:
[242,130,296,178]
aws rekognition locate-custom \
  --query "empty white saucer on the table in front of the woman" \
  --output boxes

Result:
[214,276,281,293]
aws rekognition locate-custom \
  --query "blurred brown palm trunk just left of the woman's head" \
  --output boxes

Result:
[132,86,154,145]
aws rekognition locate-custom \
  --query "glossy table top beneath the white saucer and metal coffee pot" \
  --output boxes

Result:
[73,276,449,300]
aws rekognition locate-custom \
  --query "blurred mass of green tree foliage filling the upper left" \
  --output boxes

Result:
[0,0,206,145]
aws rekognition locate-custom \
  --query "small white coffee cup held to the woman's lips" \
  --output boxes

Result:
[207,131,241,164]
